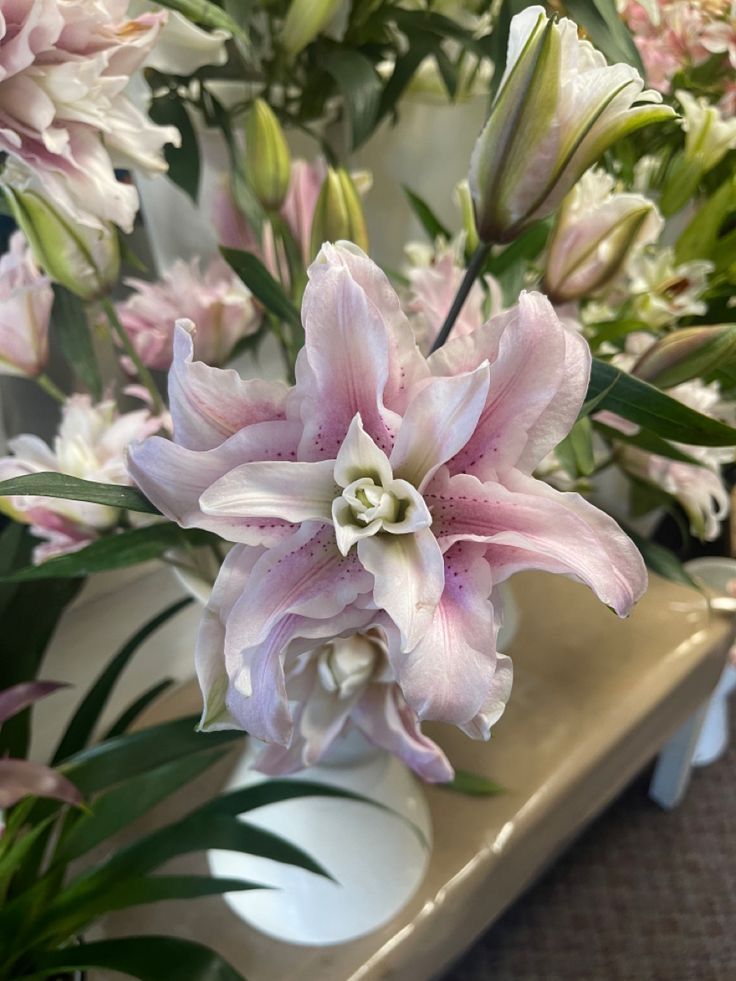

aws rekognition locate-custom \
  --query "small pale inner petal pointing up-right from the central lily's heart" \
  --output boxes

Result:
[391,362,490,492]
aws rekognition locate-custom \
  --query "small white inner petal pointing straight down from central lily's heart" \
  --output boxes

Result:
[358,528,445,650]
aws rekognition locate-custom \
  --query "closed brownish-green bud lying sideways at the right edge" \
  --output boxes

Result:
[631,324,736,388]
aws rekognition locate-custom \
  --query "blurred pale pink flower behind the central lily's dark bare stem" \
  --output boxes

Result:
[406,236,504,351]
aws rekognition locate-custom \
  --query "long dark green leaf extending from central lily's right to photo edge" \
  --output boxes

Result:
[586,358,736,446]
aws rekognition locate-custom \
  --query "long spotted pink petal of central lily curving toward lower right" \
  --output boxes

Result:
[425,470,647,616]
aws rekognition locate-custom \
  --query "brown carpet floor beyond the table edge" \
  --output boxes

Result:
[443,716,736,981]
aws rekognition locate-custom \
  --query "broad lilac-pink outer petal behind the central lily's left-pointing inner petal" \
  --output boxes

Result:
[128,420,300,545]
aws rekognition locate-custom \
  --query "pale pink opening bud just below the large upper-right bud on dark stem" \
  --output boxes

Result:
[544,169,663,303]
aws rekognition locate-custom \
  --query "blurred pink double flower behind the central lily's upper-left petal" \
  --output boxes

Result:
[117,257,261,370]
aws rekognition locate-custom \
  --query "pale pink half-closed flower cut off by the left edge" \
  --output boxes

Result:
[0,232,54,377]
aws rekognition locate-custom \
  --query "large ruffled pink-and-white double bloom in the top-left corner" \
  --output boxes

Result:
[0,0,179,231]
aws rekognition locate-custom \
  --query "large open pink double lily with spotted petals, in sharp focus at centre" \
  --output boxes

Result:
[130,243,646,772]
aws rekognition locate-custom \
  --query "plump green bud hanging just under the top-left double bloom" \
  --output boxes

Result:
[5,187,120,300]
